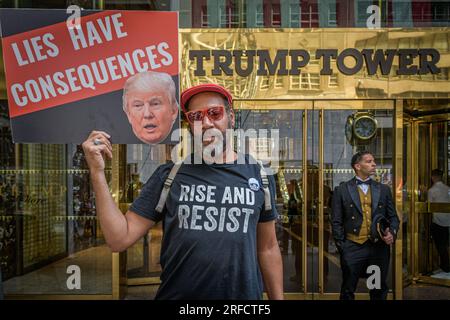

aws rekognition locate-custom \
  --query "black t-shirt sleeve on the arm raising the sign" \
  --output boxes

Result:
[129,163,173,222]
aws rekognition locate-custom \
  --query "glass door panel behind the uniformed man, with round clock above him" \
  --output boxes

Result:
[317,107,395,298]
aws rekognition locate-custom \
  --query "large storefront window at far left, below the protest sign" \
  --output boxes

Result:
[0,101,112,296]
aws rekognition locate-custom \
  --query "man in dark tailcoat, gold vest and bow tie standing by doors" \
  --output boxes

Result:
[331,151,399,300]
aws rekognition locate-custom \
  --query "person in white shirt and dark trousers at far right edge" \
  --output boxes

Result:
[428,169,450,279]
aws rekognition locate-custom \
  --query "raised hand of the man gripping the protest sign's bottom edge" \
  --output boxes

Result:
[81,131,112,173]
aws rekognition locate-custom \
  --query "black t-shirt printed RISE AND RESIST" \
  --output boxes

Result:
[130,157,278,299]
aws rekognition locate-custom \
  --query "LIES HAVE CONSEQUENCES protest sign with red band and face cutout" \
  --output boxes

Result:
[0,9,179,144]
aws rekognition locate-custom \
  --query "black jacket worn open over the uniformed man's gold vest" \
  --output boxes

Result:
[331,178,400,247]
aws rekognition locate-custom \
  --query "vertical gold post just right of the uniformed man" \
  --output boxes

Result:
[393,100,403,300]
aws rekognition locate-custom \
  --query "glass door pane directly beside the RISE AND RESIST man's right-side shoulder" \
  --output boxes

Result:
[237,110,306,293]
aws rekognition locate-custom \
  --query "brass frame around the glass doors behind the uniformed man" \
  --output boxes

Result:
[234,99,403,300]
